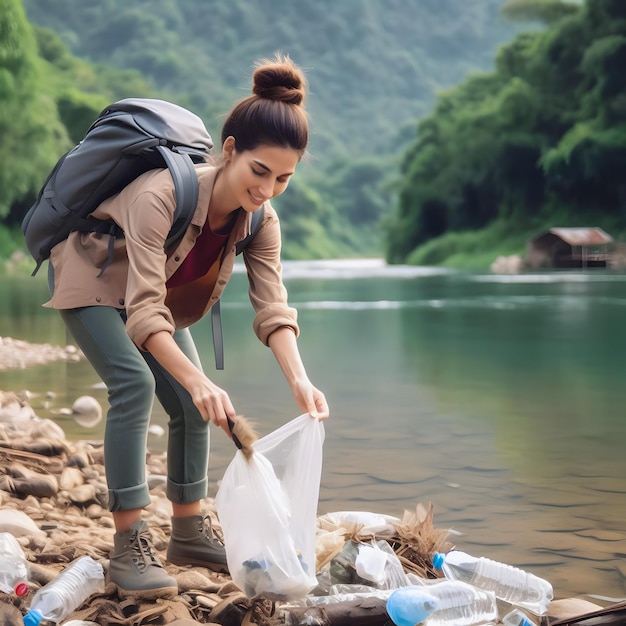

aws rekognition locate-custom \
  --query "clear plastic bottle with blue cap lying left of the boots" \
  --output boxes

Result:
[24,556,104,626]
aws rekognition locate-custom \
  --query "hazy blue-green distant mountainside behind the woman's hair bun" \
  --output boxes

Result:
[24,0,514,157]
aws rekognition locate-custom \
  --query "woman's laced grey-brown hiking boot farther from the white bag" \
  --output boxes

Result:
[109,520,178,599]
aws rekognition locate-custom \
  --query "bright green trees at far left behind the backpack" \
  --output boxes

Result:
[0,0,156,224]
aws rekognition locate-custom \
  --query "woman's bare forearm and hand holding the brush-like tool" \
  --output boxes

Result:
[144,331,237,437]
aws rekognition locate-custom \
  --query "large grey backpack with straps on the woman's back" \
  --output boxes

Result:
[22,98,263,369]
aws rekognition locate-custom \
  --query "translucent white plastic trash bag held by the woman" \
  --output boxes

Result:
[215,414,324,600]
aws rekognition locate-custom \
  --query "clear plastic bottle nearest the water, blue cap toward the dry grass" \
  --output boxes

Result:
[433,550,554,615]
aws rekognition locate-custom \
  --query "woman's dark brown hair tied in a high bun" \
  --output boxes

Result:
[222,53,309,157]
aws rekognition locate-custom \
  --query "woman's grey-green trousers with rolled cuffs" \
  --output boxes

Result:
[50,274,209,511]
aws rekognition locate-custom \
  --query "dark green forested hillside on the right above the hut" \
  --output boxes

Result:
[387,0,626,263]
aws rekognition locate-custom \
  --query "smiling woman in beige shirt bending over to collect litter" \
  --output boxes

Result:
[47,55,329,597]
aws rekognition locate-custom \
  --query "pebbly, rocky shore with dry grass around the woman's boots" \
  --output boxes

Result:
[0,338,619,626]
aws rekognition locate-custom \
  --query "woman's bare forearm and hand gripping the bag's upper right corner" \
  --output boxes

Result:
[268,327,330,420]
